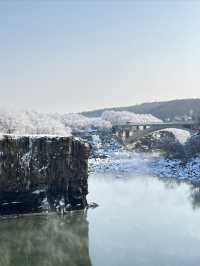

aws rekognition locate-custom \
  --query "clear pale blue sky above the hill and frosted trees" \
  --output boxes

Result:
[0,0,200,113]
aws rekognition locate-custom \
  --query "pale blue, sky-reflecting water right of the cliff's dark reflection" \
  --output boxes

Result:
[88,174,200,266]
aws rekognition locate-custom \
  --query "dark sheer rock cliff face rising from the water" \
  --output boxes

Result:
[0,135,90,213]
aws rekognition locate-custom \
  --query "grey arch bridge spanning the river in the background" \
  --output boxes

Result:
[113,121,200,143]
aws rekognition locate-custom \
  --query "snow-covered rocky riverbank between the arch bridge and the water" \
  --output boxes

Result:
[89,132,200,183]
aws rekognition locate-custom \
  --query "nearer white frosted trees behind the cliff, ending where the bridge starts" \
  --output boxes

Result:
[0,109,112,136]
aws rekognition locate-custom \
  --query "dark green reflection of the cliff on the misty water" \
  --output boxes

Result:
[0,212,91,266]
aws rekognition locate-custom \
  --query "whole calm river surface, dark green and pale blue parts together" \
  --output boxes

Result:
[0,173,200,266]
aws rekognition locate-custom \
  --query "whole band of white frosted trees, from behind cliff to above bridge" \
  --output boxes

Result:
[0,108,162,136]
